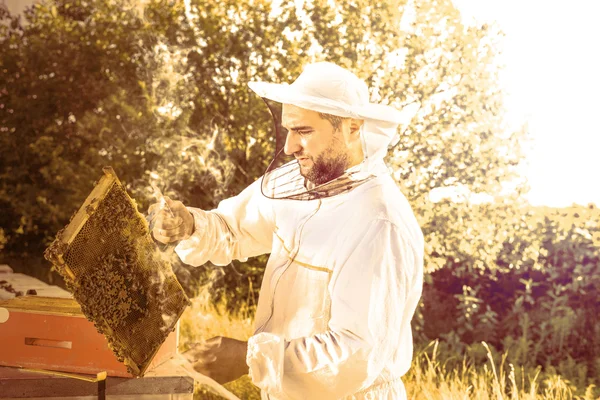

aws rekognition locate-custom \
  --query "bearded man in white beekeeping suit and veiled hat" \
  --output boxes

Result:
[153,63,424,400]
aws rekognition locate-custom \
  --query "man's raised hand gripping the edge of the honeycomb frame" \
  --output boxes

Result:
[148,196,194,243]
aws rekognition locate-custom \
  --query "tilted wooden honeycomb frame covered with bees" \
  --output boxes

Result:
[45,168,189,376]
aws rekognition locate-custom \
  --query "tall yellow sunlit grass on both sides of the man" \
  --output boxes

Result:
[180,291,600,400]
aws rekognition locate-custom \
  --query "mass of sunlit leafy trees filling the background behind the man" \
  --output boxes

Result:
[0,0,522,302]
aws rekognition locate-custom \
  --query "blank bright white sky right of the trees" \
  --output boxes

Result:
[454,0,600,207]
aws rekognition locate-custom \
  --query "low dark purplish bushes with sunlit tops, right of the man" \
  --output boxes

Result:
[415,204,600,387]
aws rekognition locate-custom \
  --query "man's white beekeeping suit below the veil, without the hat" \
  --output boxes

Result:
[176,62,424,400]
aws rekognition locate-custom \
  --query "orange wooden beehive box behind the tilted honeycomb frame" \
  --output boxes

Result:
[0,296,178,377]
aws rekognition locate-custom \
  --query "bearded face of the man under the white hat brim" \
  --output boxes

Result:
[282,104,349,185]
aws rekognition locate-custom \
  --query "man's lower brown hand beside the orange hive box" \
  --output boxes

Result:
[184,336,248,384]
